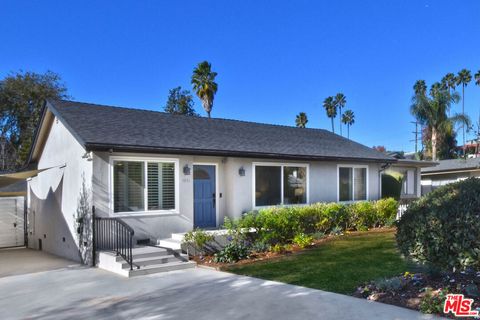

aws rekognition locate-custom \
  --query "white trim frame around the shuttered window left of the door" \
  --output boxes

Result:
[108,156,180,217]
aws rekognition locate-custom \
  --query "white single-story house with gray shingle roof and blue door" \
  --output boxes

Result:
[27,101,432,260]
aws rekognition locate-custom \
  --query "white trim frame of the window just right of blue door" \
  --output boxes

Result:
[252,162,310,209]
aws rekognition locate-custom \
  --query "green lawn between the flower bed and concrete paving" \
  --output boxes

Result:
[226,232,413,294]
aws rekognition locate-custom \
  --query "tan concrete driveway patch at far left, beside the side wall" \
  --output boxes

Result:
[0,247,78,278]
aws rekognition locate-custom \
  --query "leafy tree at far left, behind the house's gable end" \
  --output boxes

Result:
[0,71,68,169]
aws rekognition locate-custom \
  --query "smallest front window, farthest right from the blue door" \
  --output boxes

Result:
[338,166,367,201]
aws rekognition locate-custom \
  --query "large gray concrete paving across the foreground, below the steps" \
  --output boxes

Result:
[0,267,442,320]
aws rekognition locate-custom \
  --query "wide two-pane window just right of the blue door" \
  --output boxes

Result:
[254,165,307,207]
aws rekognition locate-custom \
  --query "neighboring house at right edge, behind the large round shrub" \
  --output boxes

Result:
[422,158,480,195]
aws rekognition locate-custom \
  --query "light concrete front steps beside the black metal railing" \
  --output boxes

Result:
[97,246,196,277]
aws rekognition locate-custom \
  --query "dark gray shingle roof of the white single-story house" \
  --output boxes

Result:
[47,100,395,162]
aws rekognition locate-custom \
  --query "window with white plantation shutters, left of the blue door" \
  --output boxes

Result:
[113,160,176,212]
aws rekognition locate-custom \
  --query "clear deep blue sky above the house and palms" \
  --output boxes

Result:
[0,0,480,151]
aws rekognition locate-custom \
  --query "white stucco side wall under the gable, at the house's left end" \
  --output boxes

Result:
[27,119,92,261]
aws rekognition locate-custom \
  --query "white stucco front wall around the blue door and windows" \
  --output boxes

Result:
[92,152,380,239]
